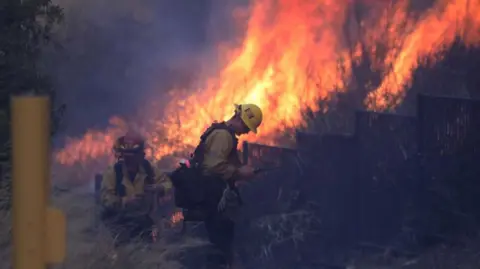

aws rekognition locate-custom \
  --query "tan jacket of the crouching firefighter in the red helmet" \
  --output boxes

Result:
[101,161,172,210]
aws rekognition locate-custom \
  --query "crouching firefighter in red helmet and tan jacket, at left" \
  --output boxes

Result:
[101,133,171,245]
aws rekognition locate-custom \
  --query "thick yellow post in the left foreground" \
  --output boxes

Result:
[11,96,65,269]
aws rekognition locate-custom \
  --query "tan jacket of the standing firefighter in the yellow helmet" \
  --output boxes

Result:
[202,129,241,180]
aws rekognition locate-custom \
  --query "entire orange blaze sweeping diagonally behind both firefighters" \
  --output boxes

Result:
[56,0,480,165]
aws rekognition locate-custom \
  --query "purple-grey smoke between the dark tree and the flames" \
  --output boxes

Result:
[45,0,244,136]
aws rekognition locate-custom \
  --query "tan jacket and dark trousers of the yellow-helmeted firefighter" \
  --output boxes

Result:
[195,123,246,268]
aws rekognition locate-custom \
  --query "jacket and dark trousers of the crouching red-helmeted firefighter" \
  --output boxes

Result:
[101,157,172,245]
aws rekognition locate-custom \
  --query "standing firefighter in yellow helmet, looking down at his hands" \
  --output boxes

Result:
[194,104,263,268]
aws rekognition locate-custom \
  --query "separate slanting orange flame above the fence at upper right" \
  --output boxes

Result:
[366,0,480,110]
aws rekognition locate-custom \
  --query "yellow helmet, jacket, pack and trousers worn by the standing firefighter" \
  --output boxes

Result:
[171,104,263,268]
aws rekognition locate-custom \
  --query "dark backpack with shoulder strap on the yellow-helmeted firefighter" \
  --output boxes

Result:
[170,122,238,210]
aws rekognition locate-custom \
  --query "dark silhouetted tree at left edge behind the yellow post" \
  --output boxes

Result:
[0,0,64,208]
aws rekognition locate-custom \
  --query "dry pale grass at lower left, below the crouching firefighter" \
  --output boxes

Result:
[0,185,206,269]
